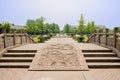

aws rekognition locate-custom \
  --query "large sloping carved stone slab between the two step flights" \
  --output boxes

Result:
[29,43,89,71]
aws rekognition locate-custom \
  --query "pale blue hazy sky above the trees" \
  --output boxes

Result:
[0,0,120,28]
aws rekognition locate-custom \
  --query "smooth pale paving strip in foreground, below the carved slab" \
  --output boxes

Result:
[22,71,95,80]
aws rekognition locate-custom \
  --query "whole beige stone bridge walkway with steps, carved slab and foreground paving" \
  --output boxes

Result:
[0,38,120,80]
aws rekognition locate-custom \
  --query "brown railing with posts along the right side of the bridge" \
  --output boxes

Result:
[88,27,120,57]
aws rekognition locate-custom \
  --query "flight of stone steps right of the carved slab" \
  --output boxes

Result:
[82,49,120,68]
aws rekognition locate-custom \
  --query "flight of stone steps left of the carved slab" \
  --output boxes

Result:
[0,50,37,68]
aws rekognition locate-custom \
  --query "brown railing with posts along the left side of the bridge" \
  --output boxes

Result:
[0,29,34,52]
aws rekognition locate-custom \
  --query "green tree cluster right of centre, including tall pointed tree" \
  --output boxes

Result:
[63,14,96,34]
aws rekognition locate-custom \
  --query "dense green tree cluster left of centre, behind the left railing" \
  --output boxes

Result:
[26,17,60,34]
